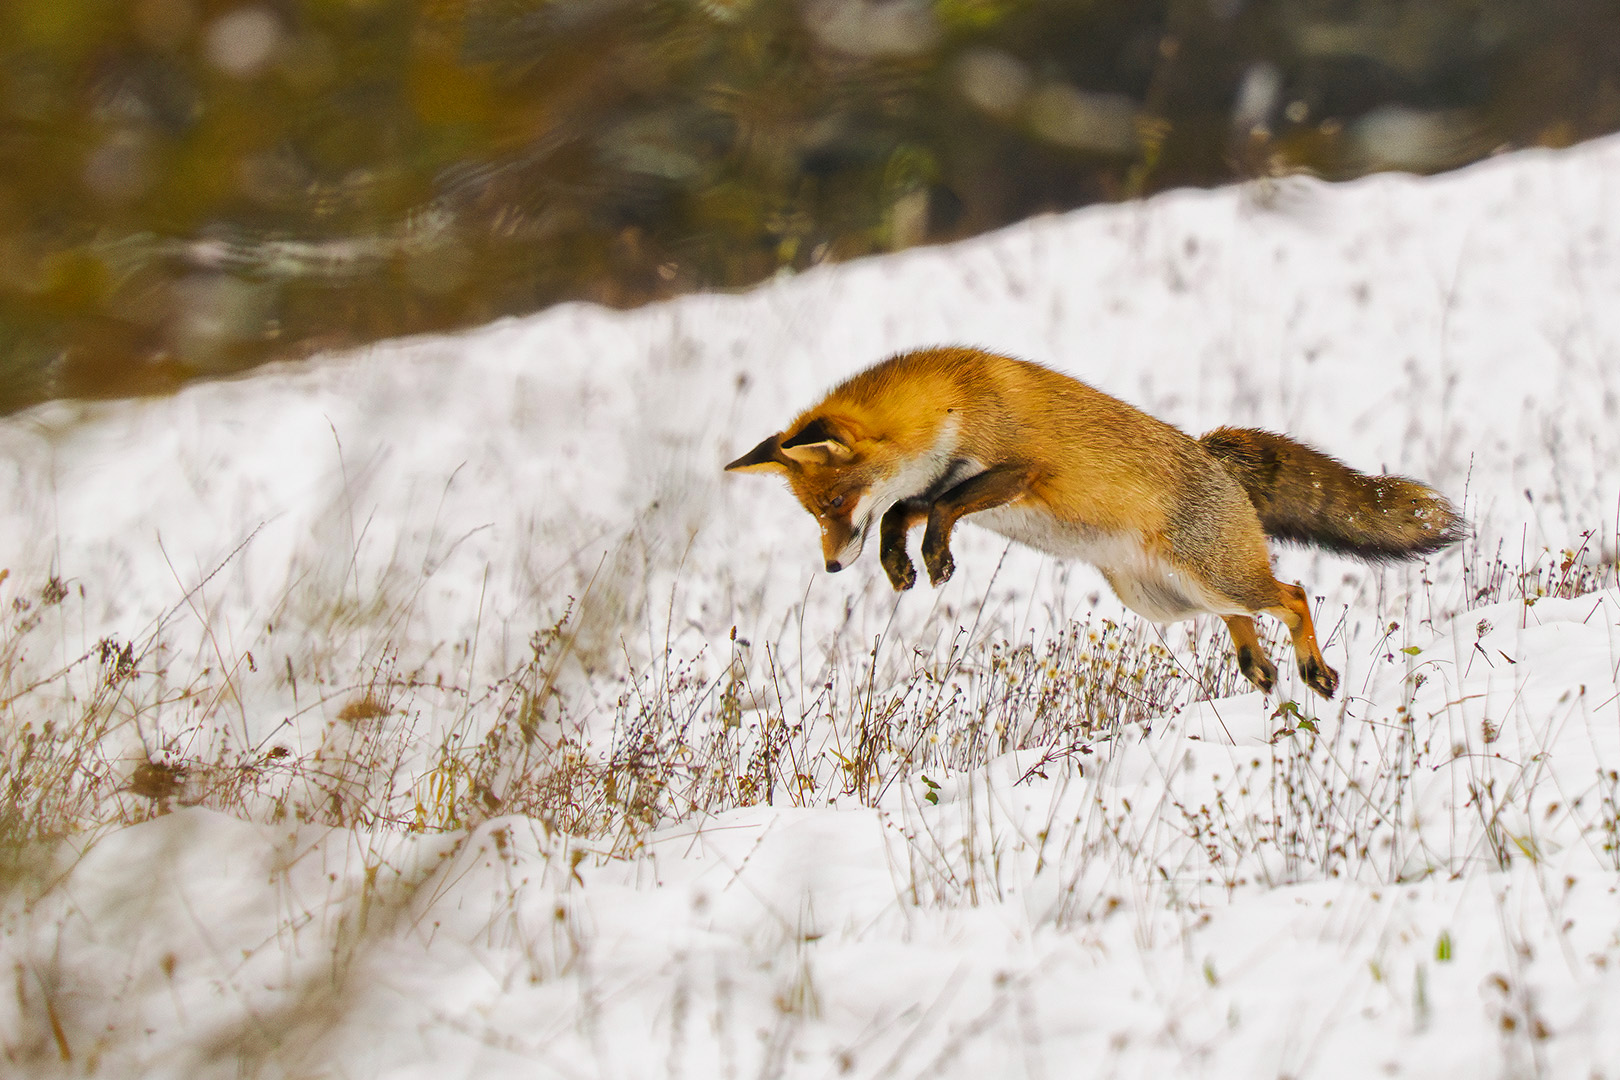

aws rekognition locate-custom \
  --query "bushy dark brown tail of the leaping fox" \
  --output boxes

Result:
[1199,427,1464,562]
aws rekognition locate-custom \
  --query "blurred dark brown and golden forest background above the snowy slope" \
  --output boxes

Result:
[0,0,1620,411]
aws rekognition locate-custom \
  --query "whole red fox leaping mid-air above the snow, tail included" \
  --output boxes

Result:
[726,348,1463,698]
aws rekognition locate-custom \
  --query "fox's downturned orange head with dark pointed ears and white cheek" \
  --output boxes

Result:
[726,416,888,573]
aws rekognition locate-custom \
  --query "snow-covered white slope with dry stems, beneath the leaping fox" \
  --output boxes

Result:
[0,141,1620,1078]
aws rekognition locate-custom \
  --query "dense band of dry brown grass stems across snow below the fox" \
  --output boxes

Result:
[0,518,1617,853]
